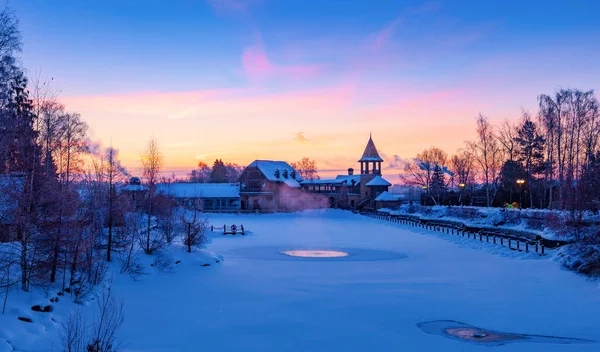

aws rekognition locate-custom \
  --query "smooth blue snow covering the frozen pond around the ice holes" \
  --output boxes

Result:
[0,210,600,352]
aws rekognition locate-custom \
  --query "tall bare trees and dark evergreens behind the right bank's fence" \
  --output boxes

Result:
[401,89,600,216]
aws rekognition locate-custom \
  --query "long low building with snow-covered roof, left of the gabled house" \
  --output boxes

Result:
[157,183,240,211]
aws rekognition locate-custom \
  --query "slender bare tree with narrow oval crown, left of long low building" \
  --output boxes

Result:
[142,138,163,254]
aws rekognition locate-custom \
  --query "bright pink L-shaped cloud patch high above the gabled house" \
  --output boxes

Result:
[242,44,322,82]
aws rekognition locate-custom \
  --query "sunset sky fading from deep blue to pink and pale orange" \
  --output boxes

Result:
[9,0,600,180]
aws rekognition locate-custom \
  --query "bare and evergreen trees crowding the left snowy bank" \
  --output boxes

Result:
[0,8,209,328]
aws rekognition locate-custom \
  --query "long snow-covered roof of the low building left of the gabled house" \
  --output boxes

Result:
[157,183,240,198]
